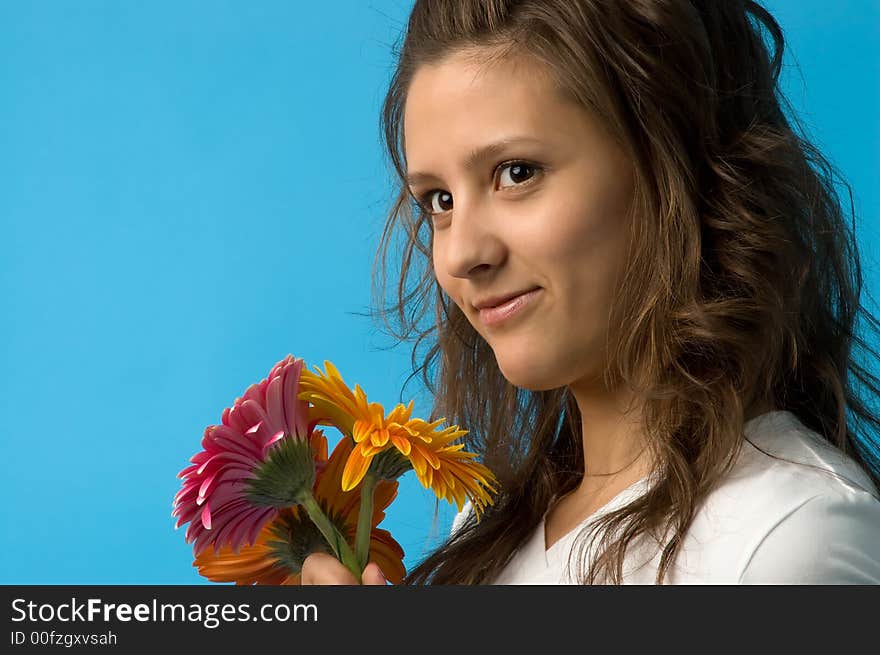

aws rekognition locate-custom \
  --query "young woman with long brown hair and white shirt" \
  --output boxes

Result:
[303,0,880,584]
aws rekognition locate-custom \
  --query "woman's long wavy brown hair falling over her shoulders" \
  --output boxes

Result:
[374,0,880,584]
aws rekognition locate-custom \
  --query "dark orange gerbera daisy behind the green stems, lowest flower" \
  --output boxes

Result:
[193,430,406,585]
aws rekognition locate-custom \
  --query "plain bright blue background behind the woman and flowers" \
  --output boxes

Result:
[0,0,880,584]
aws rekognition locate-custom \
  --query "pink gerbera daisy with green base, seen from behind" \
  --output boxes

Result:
[171,355,315,556]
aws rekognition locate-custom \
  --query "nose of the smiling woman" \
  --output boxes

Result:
[433,192,507,278]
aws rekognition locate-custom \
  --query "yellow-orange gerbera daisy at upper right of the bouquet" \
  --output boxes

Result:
[297,361,497,516]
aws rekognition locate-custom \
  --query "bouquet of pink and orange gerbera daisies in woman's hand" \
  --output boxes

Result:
[172,355,497,585]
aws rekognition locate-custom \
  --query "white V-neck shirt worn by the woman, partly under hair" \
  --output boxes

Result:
[452,411,880,584]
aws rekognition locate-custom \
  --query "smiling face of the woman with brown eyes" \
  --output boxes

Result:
[404,53,633,390]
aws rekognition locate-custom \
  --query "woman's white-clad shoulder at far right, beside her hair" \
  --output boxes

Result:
[684,411,880,584]
